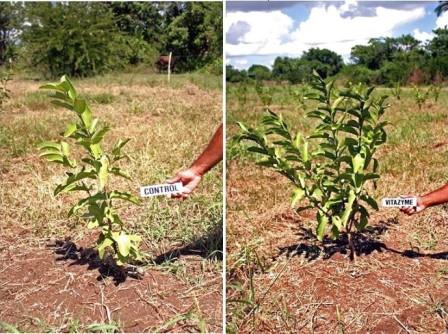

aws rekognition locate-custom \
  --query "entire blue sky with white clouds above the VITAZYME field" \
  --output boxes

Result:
[225,0,448,69]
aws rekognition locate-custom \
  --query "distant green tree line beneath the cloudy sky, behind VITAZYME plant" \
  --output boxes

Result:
[227,28,448,85]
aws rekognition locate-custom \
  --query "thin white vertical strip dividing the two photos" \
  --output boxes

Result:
[222,0,227,333]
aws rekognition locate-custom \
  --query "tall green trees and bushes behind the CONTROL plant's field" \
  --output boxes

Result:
[0,2,222,77]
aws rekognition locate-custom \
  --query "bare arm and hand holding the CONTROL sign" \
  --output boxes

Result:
[168,124,223,199]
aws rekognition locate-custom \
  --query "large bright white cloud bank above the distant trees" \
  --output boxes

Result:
[226,0,426,59]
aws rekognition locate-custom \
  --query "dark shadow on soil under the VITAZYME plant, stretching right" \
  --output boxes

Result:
[273,218,448,262]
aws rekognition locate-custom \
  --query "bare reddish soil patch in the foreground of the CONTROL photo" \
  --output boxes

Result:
[0,234,222,332]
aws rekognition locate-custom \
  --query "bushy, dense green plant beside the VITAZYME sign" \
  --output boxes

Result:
[238,72,388,259]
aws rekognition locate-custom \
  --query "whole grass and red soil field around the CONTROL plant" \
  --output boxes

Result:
[0,72,222,332]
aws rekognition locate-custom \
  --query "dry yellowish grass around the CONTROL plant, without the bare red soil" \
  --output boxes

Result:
[0,73,222,331]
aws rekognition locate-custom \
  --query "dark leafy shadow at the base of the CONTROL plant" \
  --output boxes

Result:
[47,239,141,286]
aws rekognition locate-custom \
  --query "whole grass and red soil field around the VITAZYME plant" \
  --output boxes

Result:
[227,84,448,333]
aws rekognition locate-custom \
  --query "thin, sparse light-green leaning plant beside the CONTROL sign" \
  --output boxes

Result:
[39,76,141,266]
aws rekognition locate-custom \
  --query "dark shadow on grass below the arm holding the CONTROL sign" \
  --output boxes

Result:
[153,224,223,265]
